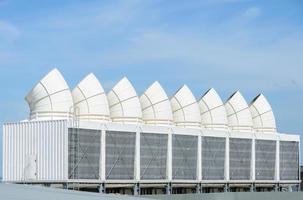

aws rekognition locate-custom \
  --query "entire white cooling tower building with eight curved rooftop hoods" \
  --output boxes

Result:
[3,69,300,194]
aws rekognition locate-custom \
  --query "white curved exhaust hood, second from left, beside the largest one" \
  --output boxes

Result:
[72,73,110,122]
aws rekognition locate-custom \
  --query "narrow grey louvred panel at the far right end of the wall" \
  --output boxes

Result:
[280,141,299,180]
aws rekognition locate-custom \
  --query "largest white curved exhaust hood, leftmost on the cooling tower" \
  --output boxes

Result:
[25,69,73,120]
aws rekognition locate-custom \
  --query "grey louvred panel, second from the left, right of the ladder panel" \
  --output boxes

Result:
[106,131,136,180]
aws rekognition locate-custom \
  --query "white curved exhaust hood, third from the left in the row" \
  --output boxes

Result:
[107,77,142,123]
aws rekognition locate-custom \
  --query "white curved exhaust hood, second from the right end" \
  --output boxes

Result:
[225,91,253,132]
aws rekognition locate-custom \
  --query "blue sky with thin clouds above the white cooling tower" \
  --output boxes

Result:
[0,0,303,175]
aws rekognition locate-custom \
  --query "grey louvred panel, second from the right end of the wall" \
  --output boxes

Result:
[255,140,276,180]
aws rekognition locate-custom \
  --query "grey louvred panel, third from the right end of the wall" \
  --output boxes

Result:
[229,138,252,180]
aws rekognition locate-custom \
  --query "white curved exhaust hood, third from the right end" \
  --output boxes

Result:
[199,88,228,130]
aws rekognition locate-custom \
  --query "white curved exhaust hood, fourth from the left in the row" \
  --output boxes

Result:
[140,81,173,125]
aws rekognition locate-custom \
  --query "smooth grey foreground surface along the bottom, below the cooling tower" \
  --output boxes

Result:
[0,184,303,200]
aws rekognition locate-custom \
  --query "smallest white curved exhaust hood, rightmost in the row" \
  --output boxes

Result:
[250,94,276,133]
